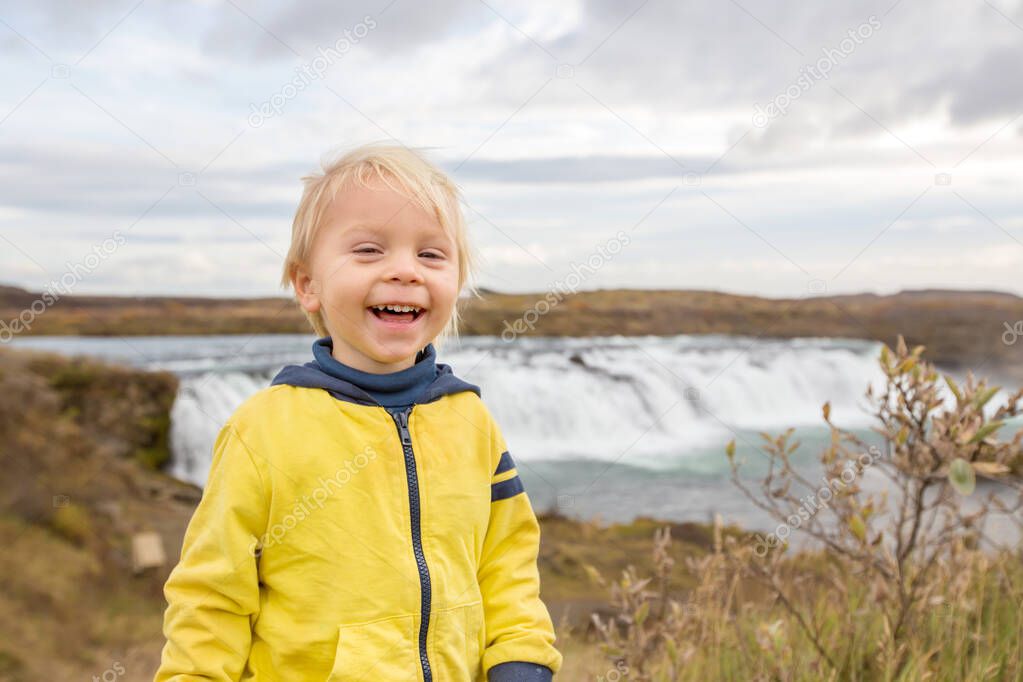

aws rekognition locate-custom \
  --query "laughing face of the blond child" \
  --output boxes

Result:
[295,179,458,373]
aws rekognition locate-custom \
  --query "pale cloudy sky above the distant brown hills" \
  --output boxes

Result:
[0,0,1023,298]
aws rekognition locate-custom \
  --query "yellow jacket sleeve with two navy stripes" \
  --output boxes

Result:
[477,420,562,682]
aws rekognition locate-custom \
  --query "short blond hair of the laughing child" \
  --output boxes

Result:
[280,143,479,350]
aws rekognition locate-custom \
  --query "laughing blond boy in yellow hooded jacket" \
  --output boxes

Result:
[155,145,562,682]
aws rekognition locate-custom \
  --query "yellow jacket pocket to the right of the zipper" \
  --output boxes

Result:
[430,600,486,682]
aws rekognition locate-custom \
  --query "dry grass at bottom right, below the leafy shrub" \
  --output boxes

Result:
[559,531,1023,682]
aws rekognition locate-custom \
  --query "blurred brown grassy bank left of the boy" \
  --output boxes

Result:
[0,350,198,682]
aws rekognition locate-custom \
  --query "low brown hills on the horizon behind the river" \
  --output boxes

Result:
[0,286,1023,375]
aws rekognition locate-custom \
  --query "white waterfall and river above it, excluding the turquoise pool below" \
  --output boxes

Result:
[7,334,880,485]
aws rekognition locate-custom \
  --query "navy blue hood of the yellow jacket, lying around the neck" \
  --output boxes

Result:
[270,338,482,406]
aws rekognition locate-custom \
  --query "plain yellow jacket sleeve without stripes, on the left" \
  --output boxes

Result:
[154,421,269,682]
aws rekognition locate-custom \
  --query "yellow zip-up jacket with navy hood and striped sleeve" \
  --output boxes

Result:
[154,349,562,682]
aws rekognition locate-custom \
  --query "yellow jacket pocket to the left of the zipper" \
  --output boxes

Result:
[327,615,419,682]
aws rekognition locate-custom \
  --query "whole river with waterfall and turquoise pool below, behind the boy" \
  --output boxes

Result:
[12,334,1023,530]
